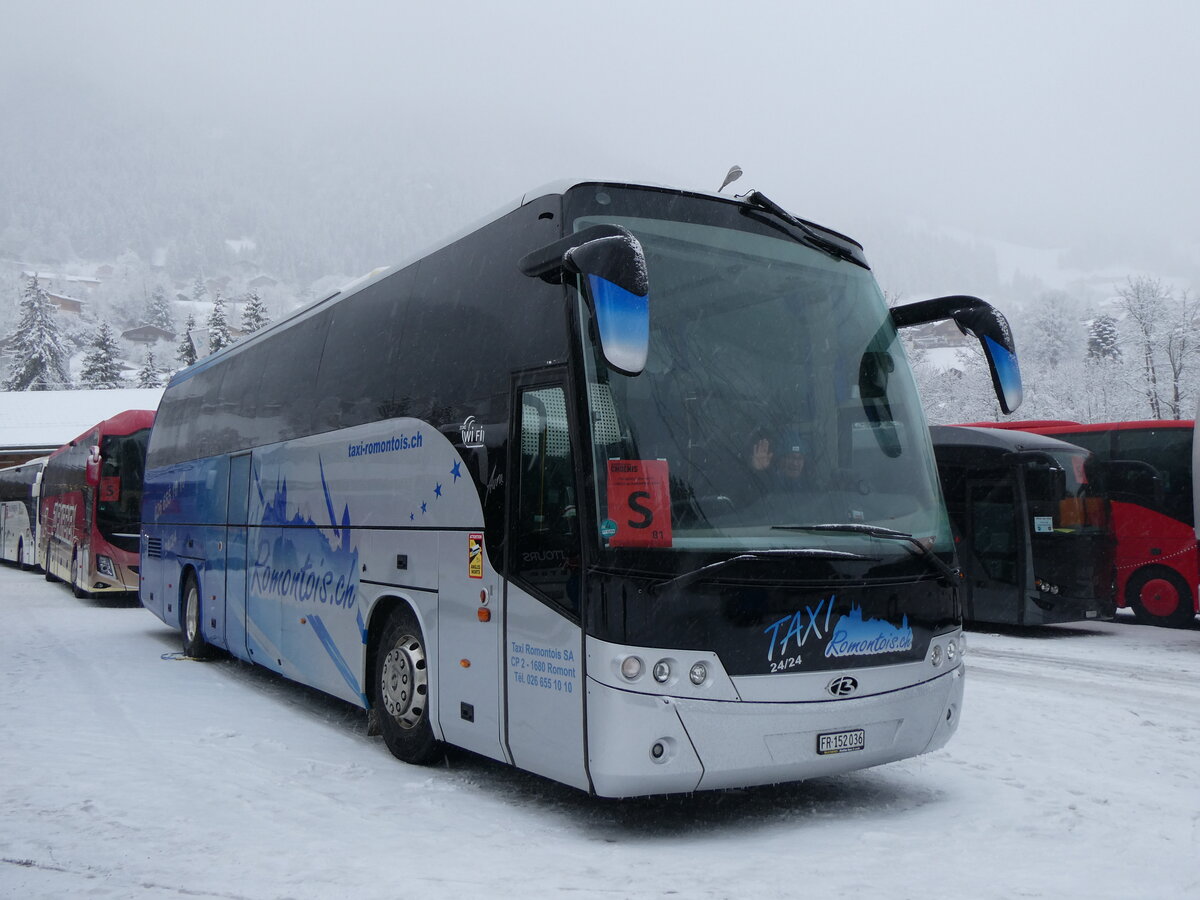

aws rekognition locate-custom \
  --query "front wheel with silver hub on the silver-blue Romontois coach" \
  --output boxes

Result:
[371,606,444,766]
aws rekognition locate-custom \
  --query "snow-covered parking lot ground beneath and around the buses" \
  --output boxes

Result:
[0,568,1200,900]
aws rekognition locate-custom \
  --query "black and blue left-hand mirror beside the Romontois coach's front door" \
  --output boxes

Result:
[520,224,650,376]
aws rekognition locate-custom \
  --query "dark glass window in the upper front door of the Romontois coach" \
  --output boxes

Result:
[512,388,580,613]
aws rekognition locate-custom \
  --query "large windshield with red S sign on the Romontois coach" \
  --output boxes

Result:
[571,187,950,569]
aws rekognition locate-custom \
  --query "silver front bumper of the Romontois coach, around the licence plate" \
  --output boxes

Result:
[587,664,966,797]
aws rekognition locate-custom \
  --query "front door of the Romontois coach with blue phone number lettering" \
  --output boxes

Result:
[504,384,589,790]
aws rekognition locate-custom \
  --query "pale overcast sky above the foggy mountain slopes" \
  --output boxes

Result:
[0,0,1200,274]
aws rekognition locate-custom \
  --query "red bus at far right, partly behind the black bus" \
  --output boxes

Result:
[972,419,1200,628]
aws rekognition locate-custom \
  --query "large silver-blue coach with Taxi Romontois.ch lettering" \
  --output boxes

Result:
[142,182,1020,797]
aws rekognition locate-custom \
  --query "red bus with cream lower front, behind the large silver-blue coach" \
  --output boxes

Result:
[37,409,155,598]
